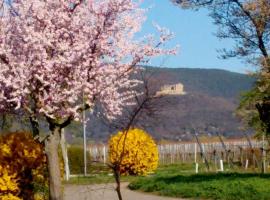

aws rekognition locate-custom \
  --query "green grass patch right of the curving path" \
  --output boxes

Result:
[129,165,270,200]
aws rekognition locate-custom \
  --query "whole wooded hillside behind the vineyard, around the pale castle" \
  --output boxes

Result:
[76,67,255,140]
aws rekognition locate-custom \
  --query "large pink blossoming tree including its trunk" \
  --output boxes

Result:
[0,0,174,200]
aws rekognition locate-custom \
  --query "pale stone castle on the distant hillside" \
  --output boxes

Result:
[156,83,186,96]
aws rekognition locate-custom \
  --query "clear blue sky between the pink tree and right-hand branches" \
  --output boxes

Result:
[139,0,252,73]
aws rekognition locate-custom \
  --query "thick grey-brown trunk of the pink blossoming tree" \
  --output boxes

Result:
[45,127,63,200]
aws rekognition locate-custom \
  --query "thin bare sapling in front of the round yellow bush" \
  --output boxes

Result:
[93,69,166,200]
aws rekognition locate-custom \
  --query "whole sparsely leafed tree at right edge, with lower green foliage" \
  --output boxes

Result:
[171,0,270,139]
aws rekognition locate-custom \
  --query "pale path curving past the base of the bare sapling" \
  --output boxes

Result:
[64,183,185,200]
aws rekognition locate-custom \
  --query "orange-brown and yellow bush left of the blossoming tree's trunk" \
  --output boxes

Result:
[0,132,48,200]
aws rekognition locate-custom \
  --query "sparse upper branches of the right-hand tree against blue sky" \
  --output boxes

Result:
[172,0,270,66]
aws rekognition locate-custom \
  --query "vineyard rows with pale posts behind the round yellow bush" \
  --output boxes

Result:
[85,139,268,170]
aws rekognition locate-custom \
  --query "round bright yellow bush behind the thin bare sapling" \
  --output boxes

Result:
[109,128,158,175]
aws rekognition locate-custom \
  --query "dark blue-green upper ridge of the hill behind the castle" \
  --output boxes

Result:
[146,67,255,98]
